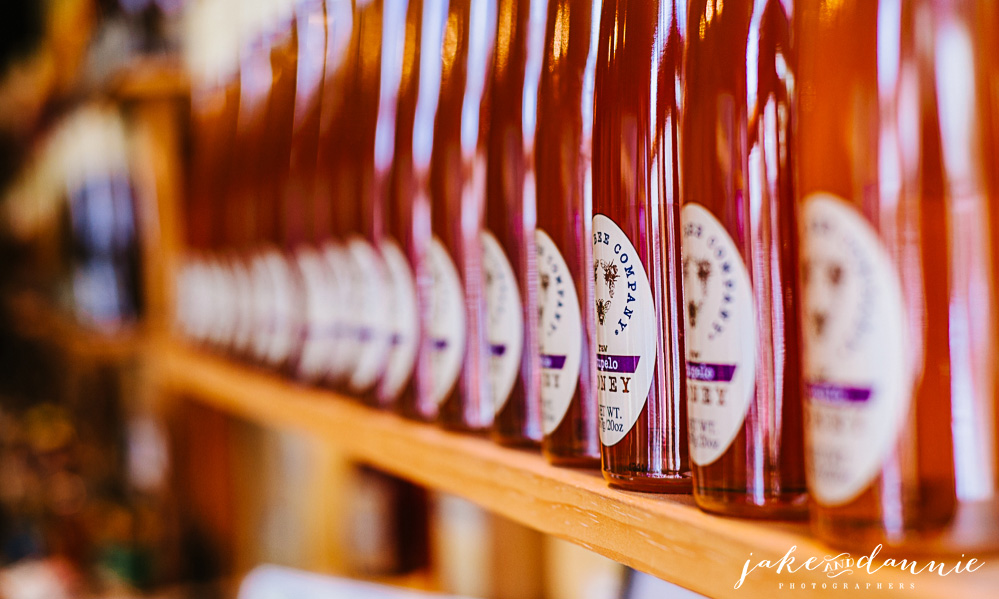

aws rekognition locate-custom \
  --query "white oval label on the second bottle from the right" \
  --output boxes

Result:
[680,204,756,466]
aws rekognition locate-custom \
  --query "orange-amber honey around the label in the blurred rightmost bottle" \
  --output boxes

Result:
[795,0,999,553]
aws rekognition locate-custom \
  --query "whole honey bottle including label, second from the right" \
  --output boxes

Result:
[681,0,807,518]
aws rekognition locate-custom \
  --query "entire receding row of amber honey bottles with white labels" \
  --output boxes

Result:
[179,0,999,551]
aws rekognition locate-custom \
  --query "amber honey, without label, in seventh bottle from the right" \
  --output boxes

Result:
[385,0,443,420]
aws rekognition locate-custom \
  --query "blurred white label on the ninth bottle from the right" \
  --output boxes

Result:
[321,241,358,383]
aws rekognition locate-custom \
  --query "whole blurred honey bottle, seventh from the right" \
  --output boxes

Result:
[381,0,447,420]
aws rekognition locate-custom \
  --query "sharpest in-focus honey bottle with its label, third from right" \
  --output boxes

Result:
[593,0,690,492]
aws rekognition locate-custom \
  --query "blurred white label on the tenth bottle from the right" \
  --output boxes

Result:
[296,247,337,381]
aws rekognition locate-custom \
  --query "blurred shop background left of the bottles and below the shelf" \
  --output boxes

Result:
[0,0,708,599]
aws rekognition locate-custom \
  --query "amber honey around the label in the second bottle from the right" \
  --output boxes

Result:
[683,0,807,518]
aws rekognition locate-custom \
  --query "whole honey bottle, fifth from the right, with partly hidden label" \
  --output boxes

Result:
[482,0,548,445]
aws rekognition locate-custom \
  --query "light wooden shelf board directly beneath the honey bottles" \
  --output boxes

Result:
[152,340,999,598]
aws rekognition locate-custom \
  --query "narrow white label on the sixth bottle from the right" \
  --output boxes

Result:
[427,237,466,406]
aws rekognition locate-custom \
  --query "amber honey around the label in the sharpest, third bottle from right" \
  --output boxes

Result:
[593,0,690,492]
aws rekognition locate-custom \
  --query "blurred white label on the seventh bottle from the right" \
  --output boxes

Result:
[381,239,419,399]
